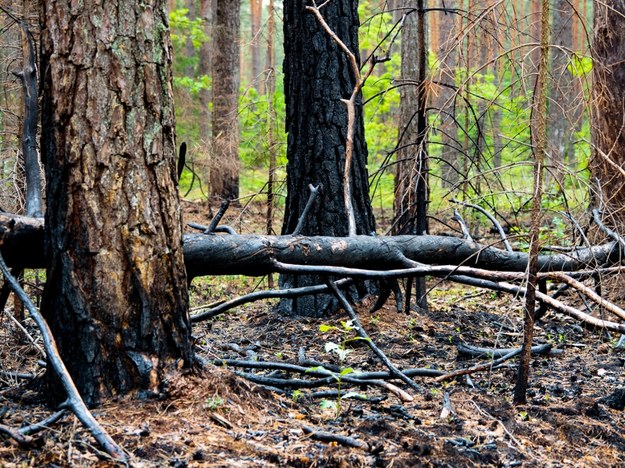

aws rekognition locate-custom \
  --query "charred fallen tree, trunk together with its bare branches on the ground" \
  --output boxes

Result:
[0,210,625,456]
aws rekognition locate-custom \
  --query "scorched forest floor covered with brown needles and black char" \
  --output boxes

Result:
[0,199,625,467]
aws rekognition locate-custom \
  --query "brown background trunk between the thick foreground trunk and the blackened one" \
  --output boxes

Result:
[210,0,241,200]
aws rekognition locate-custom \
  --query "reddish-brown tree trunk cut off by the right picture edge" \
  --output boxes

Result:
[591,0,625,228]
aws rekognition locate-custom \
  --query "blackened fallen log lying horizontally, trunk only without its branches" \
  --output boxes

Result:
[0,213,621,279]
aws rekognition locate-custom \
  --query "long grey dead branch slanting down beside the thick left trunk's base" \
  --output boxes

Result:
[0,254,126,461]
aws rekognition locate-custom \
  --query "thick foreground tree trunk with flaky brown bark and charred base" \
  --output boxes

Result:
[41,0,192,404]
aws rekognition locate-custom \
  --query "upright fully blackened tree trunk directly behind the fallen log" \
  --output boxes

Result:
[281,0,375,315]
